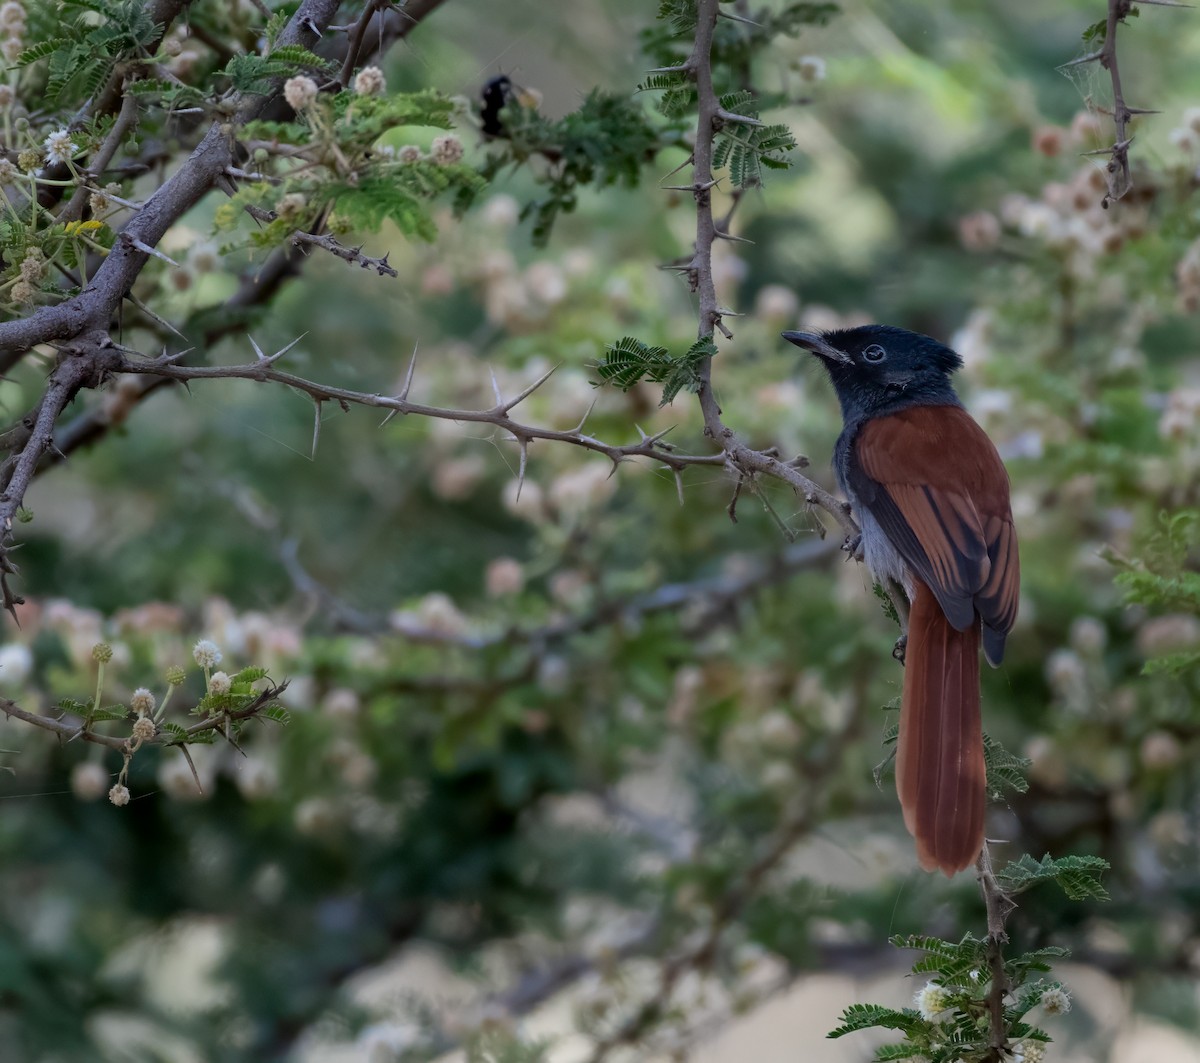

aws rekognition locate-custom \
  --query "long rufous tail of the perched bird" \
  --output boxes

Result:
[896,581,986,876]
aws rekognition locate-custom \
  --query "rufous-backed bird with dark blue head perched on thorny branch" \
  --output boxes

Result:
[782,325,1021,876]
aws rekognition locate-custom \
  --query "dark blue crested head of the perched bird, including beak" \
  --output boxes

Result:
[784,325,962,425]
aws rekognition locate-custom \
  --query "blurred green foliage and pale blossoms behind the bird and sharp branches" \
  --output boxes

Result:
[0,0,1200,1063]
